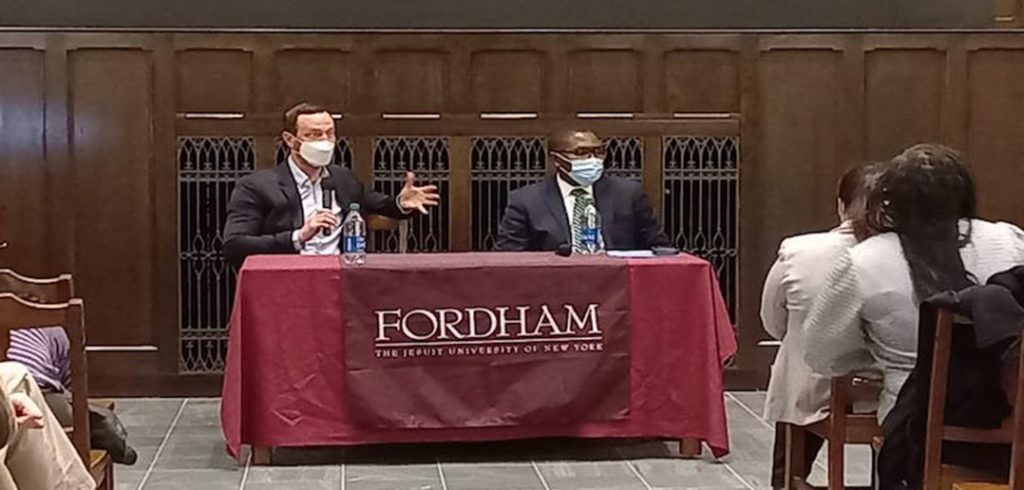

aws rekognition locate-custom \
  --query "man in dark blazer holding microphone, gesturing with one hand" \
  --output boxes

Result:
[224,102,438,268]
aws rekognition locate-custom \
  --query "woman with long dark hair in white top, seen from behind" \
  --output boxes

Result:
[804,144,1024,424]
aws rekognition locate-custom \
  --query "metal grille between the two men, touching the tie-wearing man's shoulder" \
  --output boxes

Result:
[470,136,548,251]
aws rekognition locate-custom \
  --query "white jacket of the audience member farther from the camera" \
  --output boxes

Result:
[761,222,873,426]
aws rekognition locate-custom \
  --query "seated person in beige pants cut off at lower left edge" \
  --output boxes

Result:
[0,362,96,490]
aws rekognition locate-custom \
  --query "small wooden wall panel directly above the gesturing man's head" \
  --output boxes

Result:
[273,49,351,114]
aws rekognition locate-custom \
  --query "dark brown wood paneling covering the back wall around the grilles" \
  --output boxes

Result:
[0,32,1024,395]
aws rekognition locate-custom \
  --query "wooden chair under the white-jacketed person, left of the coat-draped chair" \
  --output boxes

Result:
[785,375,882,489]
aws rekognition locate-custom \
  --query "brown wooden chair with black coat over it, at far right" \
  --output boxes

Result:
[924,310,1024,490]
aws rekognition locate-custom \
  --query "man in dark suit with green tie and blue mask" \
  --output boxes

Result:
[496,130,671,252]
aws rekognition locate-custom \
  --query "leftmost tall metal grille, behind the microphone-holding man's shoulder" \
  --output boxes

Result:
[177,136,256,373]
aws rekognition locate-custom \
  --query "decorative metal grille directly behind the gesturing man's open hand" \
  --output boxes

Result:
[370,136,452,252]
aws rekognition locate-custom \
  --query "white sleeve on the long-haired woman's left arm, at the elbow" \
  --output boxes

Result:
[804,251,871,376]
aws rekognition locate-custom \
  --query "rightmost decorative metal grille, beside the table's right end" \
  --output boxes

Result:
[663,136,739,320]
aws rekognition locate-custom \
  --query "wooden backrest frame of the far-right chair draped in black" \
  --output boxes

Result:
[919,309,1024,490]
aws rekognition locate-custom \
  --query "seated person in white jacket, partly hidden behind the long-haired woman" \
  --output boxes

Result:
[761,166,873,488]
